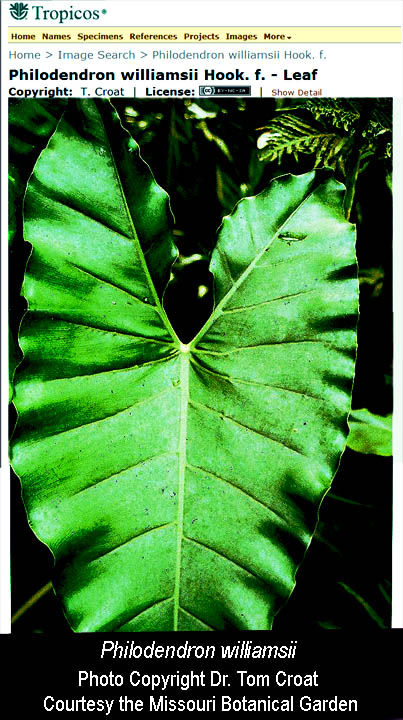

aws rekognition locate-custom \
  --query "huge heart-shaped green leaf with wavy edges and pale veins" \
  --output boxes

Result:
[12,101,357,631]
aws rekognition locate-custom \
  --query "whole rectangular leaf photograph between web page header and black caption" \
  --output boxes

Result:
[9,99,392,632]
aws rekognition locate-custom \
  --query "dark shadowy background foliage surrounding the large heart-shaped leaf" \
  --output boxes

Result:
[10,99,392,633]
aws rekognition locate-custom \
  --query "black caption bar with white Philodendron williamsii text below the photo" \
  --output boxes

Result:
[1,630,403,720]
